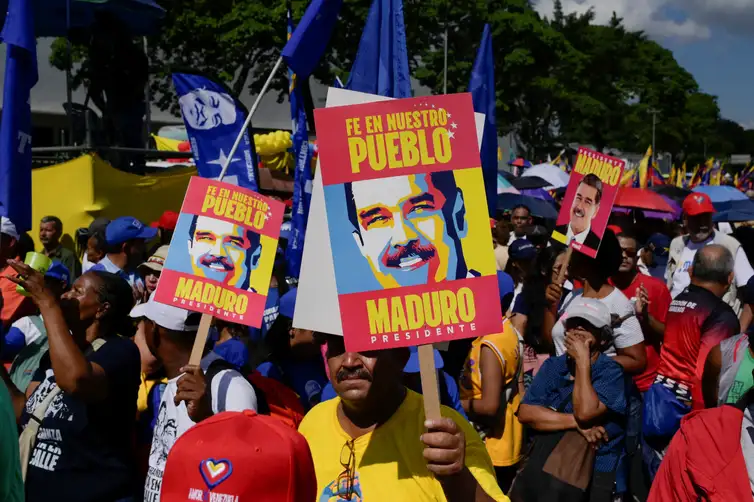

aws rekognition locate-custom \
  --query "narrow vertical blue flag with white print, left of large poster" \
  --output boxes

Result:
[285,11,313,279]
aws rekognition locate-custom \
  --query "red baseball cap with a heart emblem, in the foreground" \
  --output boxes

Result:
[160,410,317,502]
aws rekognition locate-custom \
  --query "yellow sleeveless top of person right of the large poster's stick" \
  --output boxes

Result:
[459,319,523,467]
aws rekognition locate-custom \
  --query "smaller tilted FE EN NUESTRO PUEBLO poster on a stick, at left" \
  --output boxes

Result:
[154,176,284,328]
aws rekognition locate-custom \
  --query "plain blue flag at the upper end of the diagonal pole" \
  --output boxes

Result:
[283,0,343,78]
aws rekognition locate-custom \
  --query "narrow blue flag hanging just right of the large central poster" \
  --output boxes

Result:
[469,24,497,216]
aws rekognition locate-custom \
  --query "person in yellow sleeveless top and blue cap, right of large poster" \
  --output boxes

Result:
[459,272,523,492]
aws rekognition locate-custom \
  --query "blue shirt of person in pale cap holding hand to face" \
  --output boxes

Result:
[521,354,628,472]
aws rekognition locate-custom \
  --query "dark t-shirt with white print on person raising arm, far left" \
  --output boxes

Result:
[21,336,141,502]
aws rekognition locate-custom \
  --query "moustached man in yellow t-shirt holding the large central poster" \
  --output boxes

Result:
[299,336,509,502]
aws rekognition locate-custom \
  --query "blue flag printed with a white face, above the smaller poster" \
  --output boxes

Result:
[173,73,259,192]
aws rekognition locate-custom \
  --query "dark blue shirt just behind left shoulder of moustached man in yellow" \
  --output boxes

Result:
[257,359,329,411]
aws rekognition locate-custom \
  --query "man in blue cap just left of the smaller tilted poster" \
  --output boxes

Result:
[91,216,157,303]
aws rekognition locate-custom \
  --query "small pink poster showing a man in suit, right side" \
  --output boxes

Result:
[552,147,626,258]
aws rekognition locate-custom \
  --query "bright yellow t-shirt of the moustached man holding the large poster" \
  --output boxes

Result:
[299,390,510,502]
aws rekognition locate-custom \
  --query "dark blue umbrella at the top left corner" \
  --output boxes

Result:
[10,0,165,37]
